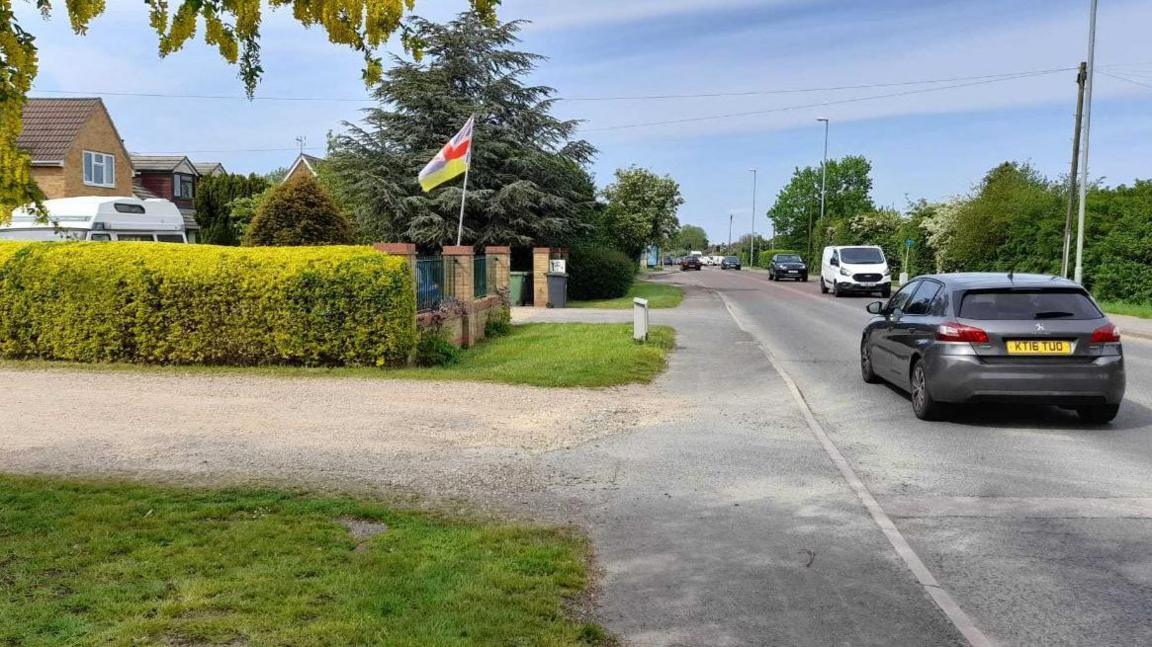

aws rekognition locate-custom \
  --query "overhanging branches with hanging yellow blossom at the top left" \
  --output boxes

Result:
[0,0,500,222]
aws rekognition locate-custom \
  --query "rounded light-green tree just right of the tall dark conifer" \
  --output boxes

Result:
[600,166,684,258]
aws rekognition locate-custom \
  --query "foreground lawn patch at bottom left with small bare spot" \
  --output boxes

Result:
[0,475,608,647]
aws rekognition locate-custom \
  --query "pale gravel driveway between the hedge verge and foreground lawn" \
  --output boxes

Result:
[0,370,680,498]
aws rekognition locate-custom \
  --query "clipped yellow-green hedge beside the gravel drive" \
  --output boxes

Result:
[0,243,417,366]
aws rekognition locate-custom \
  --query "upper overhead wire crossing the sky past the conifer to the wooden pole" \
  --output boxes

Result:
[32,67,1076,104]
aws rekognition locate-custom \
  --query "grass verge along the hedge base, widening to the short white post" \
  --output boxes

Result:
[0,324,675,387]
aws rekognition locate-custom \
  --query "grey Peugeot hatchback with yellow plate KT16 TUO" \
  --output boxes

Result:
[861,273,1124,424]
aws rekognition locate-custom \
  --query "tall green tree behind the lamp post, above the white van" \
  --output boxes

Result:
[768,155,876,252]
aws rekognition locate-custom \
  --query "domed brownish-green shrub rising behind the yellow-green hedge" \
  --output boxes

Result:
[244,175,353,246]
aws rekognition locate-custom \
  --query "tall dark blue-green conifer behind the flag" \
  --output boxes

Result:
[325,13,596,245]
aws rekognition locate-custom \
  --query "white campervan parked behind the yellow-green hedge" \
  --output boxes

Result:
[0,196,188,243]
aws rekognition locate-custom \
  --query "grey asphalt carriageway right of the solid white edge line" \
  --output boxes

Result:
[668,268,1152,646]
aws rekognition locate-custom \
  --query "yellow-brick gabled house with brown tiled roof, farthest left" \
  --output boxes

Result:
[17,98,134,199]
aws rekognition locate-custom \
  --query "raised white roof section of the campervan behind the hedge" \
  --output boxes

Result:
[0,197,184,231]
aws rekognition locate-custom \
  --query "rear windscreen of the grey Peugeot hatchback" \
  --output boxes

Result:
[960,290,1104,320]
